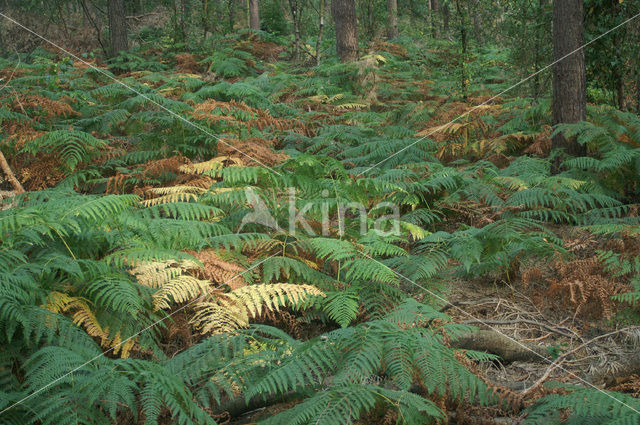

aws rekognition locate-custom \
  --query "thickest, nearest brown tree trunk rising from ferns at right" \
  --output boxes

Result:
[552,0,587,159]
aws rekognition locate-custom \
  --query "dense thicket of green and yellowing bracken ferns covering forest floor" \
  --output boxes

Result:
[0,28,640,424]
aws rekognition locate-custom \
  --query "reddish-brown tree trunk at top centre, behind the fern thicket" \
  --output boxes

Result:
[331,0,358,62]
